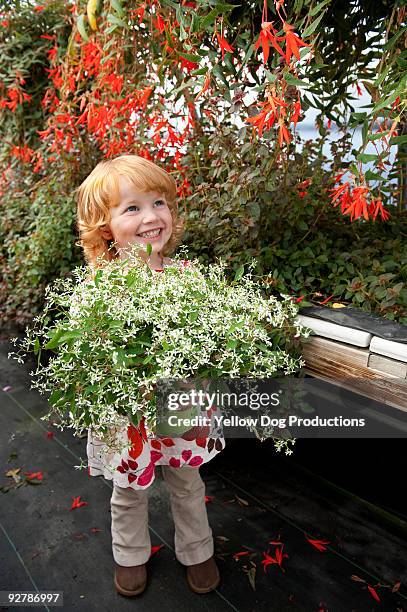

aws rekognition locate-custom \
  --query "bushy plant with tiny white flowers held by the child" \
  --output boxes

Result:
[9,249,309,450]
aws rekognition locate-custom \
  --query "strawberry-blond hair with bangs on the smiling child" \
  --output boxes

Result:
[73,154,184,267]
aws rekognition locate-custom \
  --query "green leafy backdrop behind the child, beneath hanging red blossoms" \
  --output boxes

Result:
[0,0,407,324]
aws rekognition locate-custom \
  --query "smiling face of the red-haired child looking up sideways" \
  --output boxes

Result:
[102,176,172,260]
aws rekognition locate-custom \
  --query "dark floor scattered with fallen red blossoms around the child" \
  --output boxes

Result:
[0,339,407,612]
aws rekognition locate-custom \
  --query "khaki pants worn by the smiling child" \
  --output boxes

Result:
[110,465,214,567]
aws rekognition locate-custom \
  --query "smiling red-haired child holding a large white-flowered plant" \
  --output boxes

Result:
[76,155,224,596]
